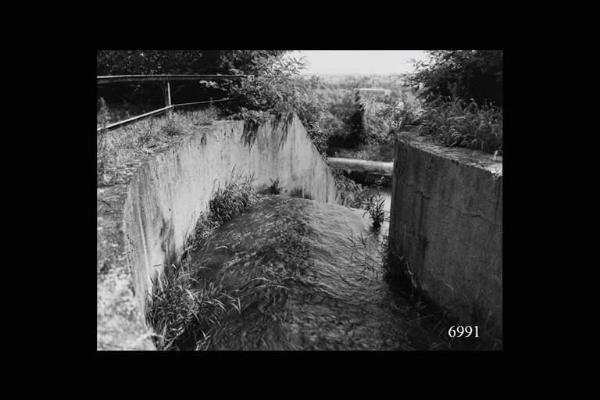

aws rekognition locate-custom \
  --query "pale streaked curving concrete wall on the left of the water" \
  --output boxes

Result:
[97,116,337,349]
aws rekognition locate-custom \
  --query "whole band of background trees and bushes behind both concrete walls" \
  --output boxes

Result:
[98,50,502,161]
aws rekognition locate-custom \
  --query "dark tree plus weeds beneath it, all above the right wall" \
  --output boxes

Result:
[409,50,503,154]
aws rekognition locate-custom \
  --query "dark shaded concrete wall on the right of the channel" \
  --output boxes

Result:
[389,133,502,332]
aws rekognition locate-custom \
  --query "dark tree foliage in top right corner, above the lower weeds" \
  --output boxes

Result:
[410,50,503,107]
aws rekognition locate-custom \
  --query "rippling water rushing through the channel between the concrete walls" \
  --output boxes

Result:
[191,189,446,350]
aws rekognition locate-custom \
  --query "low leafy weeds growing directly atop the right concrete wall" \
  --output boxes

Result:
[419,99,502,154]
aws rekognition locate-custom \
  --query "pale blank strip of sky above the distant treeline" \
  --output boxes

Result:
[290,50,427,75]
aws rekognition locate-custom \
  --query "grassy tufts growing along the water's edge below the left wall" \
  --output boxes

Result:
[146,173,257,350]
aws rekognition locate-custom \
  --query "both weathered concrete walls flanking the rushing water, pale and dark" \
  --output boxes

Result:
[97,115,502,350]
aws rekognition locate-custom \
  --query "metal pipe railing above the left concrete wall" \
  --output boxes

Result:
[97,74,248,132]
